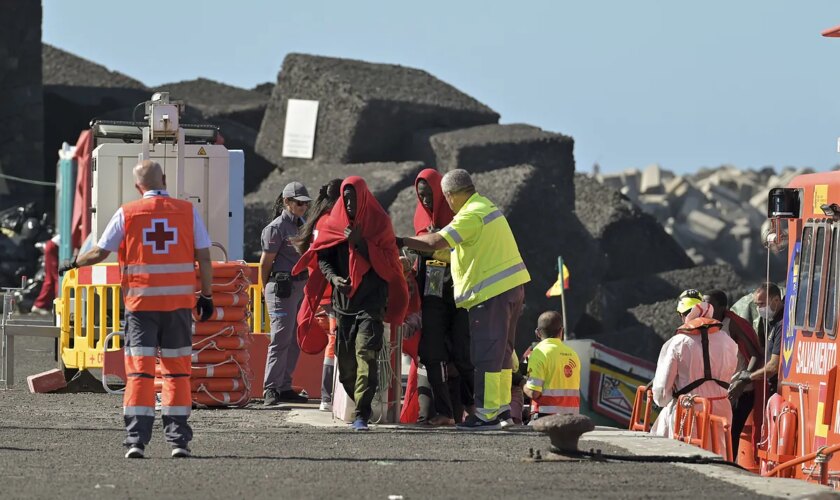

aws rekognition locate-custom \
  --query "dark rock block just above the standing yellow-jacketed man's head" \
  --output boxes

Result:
[426,124,575,211]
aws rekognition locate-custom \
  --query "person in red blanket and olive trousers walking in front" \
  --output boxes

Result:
[292,176,408,431]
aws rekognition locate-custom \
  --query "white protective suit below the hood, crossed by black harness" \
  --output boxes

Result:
[650,330,738,450]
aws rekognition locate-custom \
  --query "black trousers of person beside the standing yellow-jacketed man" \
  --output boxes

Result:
[419,297,475,420]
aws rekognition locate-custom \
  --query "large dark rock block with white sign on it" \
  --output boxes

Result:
[257,54,499,168]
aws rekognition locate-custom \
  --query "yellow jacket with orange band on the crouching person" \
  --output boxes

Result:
[525,338,580,414]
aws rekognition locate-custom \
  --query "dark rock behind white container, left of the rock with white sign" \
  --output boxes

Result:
[156,78,268,129]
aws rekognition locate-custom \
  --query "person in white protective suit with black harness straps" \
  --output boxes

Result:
[650,290,738,450]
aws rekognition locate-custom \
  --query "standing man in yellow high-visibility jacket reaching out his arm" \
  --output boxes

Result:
[397,169,531,430]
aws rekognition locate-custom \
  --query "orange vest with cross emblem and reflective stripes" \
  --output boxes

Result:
[119,196,196,311]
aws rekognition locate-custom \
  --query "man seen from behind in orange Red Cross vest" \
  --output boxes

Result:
[61,160,213,458]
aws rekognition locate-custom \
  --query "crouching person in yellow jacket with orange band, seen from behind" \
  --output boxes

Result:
[524,311,580,420]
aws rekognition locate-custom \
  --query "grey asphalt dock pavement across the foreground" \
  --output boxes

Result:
[0,339,827,499]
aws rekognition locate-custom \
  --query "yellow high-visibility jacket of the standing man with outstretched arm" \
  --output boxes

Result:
[440,193,531,309]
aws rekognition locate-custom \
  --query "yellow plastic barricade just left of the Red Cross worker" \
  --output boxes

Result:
[55,264,122,370]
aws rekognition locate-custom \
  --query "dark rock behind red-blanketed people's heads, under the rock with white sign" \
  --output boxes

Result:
[245,162,423,261]
